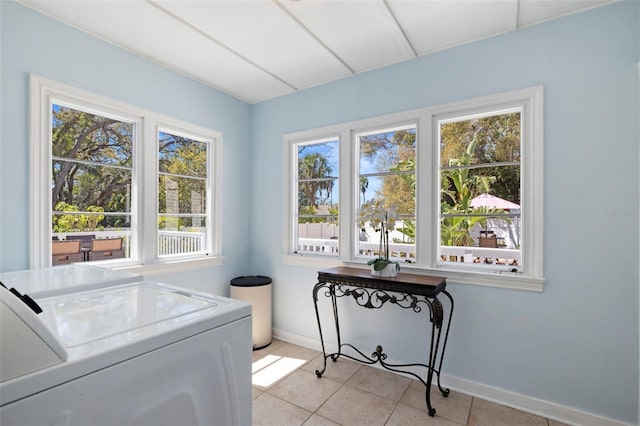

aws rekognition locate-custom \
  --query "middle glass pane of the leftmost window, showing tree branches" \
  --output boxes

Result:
[51,160,132,212]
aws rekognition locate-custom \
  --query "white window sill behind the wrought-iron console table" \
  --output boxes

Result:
[282,255,545,293]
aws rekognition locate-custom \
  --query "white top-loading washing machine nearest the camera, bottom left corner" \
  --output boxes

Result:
[0,281,252,426]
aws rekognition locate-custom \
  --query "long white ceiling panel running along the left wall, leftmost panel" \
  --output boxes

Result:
[17,1,293,102]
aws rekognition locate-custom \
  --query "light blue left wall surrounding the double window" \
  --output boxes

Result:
[0,1,250,294]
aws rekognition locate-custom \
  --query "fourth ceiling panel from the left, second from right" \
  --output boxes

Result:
[388,0,517,54]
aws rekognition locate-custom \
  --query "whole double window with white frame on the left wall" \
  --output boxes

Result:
[31,76,221,267]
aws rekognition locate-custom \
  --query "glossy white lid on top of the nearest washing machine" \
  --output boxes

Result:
[39,282,218,349]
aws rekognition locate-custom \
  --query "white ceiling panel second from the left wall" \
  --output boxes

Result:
[157,1,352,88]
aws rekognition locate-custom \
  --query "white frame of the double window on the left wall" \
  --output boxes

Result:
[29,75,223,274]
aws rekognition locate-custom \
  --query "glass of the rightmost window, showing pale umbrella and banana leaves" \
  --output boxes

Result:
[438,108,522,270]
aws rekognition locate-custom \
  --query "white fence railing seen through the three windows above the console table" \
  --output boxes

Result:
[298,238,521,265]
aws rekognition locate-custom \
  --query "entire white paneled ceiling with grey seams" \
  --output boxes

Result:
[18,0,620,103]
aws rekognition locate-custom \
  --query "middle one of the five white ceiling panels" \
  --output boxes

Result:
[280,0,415,72]
